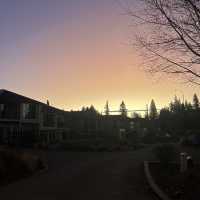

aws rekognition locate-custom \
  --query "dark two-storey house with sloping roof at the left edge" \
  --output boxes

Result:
[0,89,69,145]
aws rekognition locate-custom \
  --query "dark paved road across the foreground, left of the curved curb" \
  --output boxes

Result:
[0,150,154,200]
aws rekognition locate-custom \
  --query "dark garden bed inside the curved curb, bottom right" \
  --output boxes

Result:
[149,162,200,200]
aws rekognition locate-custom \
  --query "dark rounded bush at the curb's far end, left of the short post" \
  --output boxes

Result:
[153,144,176,166]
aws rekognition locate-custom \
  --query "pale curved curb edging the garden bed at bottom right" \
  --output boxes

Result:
[144,161,171,200]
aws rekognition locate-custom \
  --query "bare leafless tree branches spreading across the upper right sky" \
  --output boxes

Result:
[128,0,200,85]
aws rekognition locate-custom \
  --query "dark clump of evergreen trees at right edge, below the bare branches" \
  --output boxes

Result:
[158,94,200,134]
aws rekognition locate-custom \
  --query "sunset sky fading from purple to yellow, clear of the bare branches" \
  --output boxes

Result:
[0,0,200,112]
